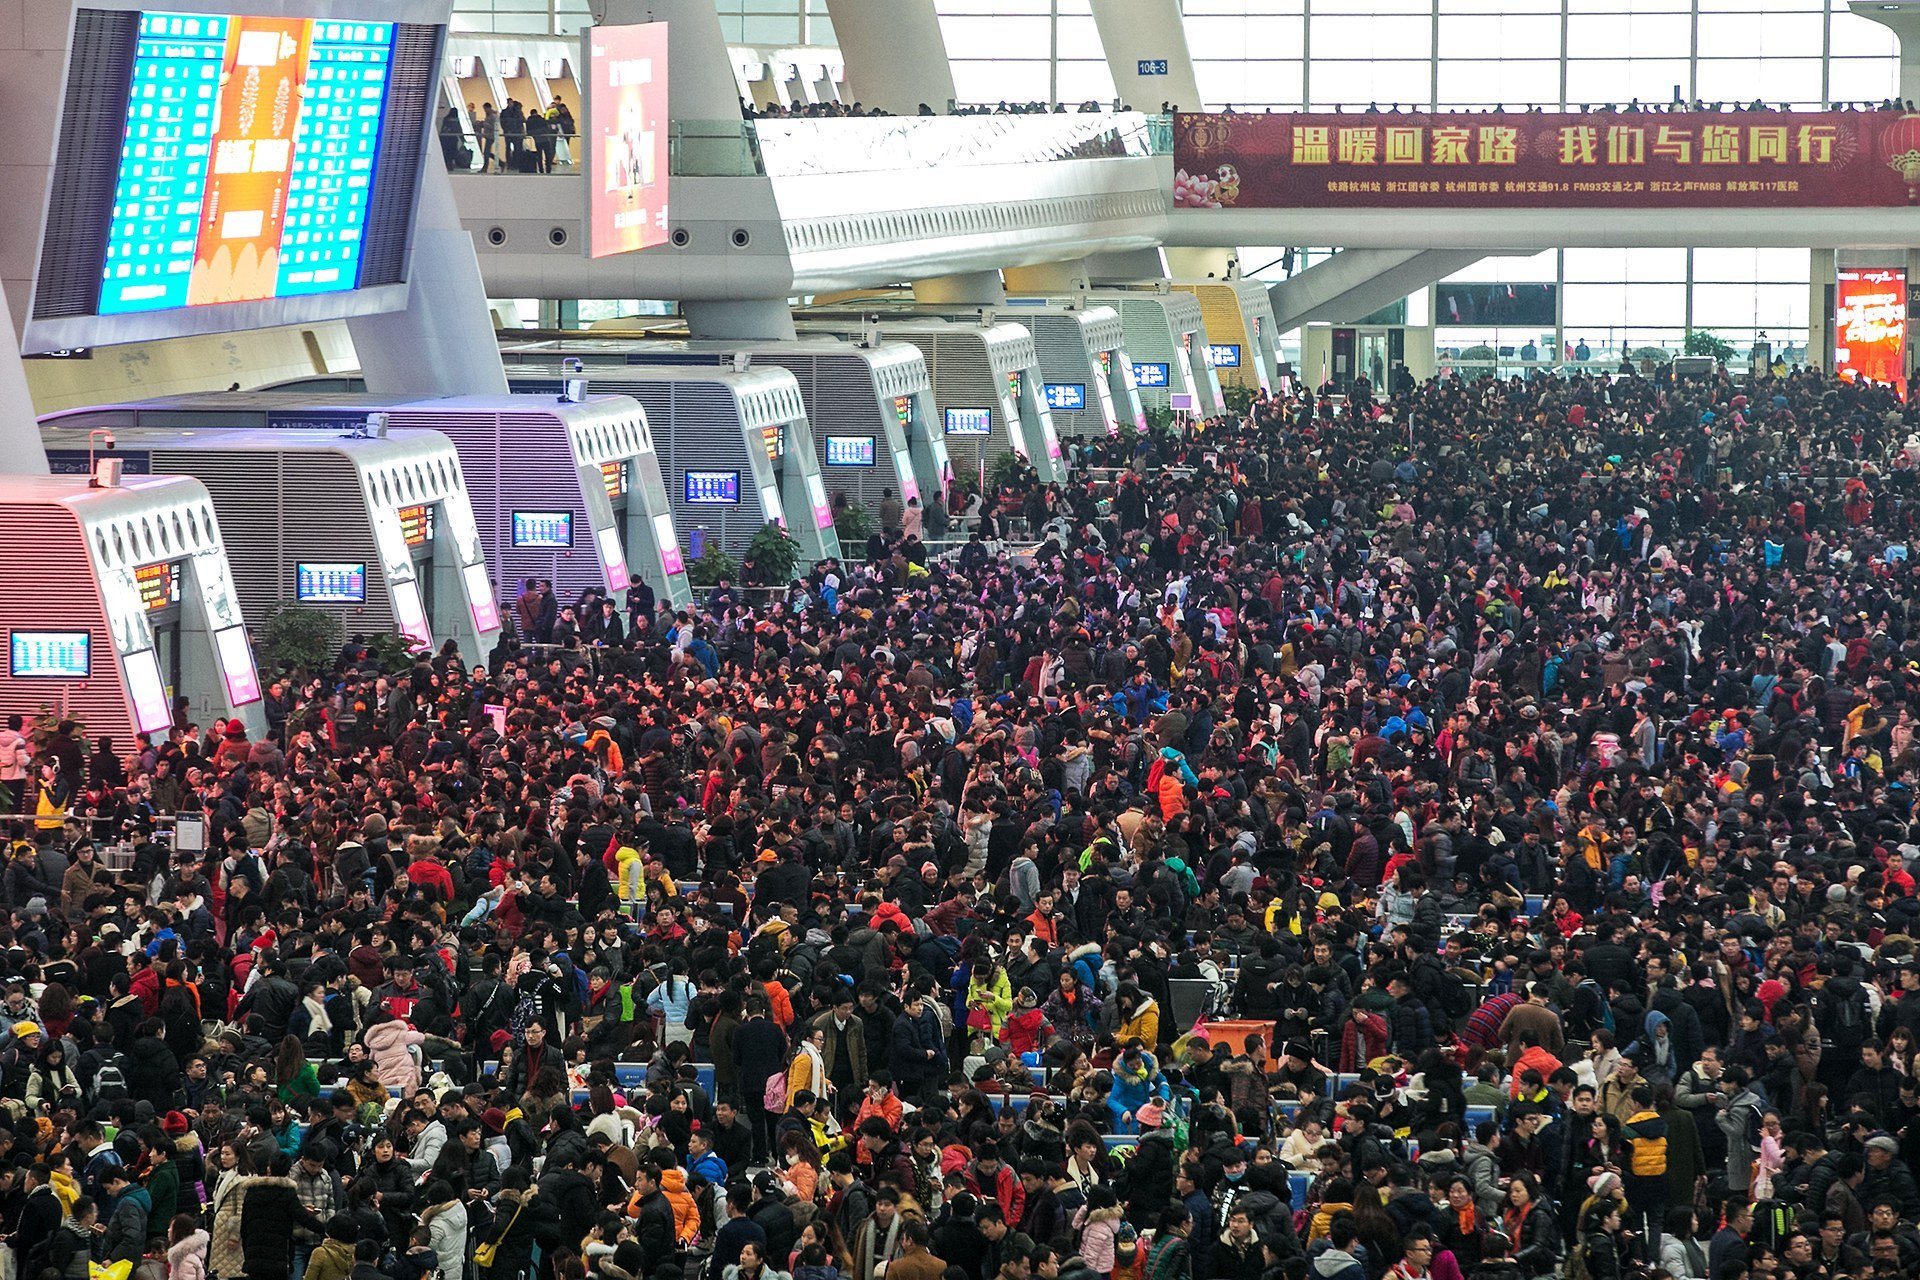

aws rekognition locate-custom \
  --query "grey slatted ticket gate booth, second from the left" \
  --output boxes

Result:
[42,416,499,662]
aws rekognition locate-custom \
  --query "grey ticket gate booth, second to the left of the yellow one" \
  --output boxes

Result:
[1002,299,1146,438]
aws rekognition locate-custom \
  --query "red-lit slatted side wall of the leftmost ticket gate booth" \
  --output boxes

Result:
[0,503,132,736]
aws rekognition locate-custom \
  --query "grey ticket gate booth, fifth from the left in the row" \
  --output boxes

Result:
[503,330,950,529]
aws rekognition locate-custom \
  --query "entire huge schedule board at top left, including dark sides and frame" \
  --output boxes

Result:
[27,0,445,349]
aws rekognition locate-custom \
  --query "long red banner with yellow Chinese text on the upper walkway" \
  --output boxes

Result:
[1173,111,1920,209]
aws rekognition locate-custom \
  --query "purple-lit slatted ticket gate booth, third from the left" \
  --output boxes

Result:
[240,387,693,604]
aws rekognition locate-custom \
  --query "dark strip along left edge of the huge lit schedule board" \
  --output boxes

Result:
[33,10,140,322]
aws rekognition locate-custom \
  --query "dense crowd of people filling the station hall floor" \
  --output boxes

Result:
[0,358,1920,1280]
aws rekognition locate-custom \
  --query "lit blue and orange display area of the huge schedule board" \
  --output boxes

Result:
[100,13,396,315]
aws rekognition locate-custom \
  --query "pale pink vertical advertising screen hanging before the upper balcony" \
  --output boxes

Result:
[582,23,668,257]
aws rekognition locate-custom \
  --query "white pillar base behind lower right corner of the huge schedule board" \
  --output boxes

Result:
[348,157,507,395]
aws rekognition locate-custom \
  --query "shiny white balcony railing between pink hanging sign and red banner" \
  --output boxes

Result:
[668,111,1173,178]
